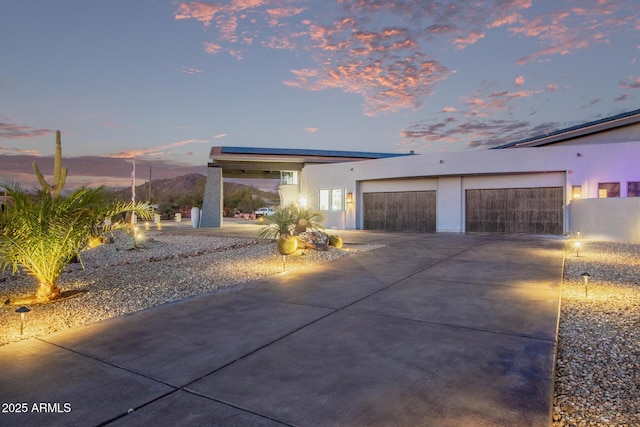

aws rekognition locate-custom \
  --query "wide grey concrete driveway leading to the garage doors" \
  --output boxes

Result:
[0,227,564,426]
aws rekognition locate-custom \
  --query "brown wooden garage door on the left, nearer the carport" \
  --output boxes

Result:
[363,190,436,231]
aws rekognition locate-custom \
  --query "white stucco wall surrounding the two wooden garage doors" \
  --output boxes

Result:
[302,142,640,232]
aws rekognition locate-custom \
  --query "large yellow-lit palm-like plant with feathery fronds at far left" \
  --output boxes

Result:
[0,184,153,302]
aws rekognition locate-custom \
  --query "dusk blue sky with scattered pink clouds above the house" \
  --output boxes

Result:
[0,0,640,191]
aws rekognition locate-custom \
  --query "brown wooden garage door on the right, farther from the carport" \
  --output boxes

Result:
[465,187,564,234]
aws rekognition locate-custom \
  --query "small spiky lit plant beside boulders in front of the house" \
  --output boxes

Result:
[258,203,324,239]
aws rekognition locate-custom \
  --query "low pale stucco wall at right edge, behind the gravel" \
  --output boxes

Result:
[569,197,640,243]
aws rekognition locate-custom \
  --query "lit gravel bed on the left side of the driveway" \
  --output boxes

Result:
[0,231,381,345]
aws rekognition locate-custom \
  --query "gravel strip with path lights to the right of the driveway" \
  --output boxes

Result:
[552,241,640,427]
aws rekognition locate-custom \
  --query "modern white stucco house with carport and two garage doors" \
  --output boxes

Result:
[202,110,640,242]
